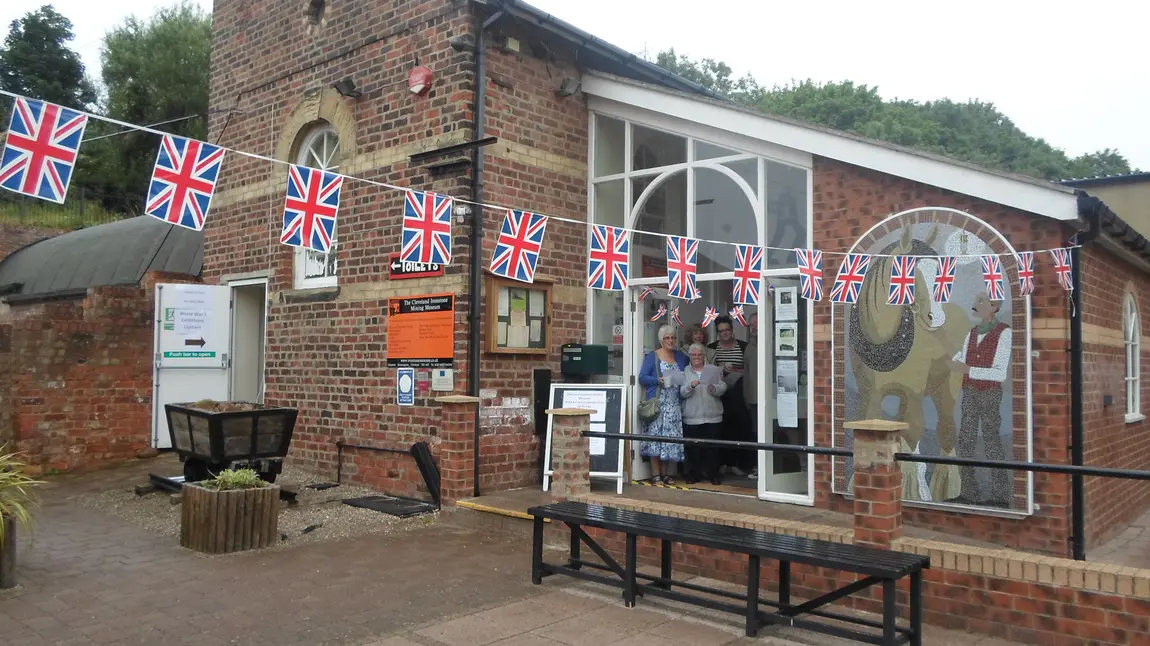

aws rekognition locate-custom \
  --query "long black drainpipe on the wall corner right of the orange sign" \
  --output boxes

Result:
[467,8,504,497]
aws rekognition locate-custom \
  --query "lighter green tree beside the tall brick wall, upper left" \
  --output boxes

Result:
[86,0,212,202]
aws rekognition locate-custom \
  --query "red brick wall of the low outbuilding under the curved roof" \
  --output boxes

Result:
[12,287,152,471]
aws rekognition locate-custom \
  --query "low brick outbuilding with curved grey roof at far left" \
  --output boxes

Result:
[0,217,204,471]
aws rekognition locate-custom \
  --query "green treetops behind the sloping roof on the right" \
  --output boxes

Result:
[656,49,1137,180]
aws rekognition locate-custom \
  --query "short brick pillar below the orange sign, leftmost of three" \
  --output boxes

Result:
[436,394,480,507]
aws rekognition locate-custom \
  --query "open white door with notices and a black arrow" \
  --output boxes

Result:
[152,284,231,448]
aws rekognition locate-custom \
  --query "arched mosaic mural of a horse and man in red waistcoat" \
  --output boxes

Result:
[834,209,1028,509]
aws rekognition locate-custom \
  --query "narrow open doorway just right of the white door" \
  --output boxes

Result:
[229,278,268,403]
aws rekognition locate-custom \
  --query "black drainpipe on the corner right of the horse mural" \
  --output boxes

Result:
[1071,191,1104,561]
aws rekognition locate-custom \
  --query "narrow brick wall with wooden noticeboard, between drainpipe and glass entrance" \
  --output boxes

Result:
[480,23,588,491]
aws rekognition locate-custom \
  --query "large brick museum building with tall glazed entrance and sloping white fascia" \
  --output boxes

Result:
[204,0,1150,556]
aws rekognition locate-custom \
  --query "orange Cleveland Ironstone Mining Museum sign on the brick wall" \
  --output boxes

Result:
[388,294,455,368]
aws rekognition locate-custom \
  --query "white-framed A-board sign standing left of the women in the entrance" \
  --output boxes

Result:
[543,384,628,493]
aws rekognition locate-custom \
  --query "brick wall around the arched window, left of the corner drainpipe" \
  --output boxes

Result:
[205,0,473,494]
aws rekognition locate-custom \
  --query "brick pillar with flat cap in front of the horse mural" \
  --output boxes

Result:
[843,420,906,548]
